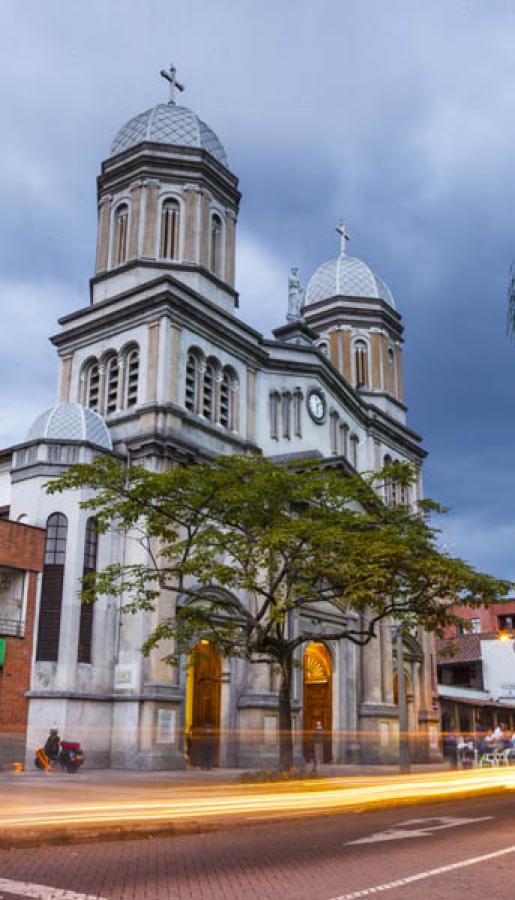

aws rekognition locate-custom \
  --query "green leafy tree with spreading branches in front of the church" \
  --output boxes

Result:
[48,456,511,769]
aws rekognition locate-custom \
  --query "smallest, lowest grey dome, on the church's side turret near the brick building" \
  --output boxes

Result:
[27,403,113,450]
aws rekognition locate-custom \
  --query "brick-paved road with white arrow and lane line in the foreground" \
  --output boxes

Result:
[0,792,515,900]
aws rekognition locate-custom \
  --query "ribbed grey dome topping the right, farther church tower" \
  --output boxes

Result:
[304,253,395,309]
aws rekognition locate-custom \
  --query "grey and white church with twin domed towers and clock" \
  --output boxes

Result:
[0,66,439,769]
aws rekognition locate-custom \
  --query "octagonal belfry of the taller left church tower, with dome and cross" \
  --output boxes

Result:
[91,64,240,311]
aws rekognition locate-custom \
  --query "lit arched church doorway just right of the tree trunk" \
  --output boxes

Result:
[304,641,333,762]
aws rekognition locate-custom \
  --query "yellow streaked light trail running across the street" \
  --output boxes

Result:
[0,768,515,836]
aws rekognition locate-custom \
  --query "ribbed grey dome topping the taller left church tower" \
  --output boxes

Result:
[111,103,229,168]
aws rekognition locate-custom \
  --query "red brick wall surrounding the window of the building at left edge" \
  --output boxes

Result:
[0,520,45,733]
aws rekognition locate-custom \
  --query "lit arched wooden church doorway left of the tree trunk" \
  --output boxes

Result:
[184,641,222,766]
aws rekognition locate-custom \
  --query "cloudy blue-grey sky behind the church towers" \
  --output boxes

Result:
[0,0,515,577]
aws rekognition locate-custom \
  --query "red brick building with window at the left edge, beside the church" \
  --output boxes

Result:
[0,508,45,766]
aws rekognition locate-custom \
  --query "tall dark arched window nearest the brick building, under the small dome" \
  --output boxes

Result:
[36,513,68,662]
